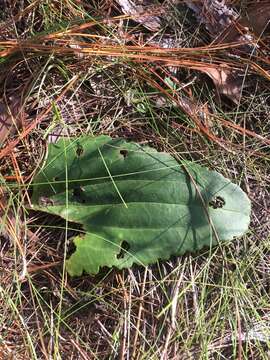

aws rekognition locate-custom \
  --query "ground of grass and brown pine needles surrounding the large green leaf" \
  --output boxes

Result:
[0,0,270,360]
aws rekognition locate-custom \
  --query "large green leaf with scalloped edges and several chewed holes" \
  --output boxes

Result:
[32,136,250,275]
